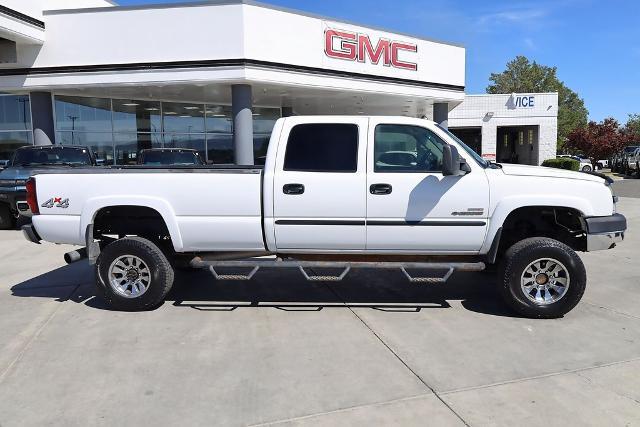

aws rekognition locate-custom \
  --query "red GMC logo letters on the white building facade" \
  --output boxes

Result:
[324,29,418,71]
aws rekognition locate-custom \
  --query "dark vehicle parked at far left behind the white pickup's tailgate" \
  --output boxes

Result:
[0,145,95,230]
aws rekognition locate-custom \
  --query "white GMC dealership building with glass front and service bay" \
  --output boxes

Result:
[0,0,558,164]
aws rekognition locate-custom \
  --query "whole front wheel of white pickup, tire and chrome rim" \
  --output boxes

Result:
[499,237,587,319]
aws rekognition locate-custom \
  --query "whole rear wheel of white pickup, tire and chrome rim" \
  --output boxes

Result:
[96,237,174,311]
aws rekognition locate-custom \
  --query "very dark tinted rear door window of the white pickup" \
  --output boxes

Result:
[284,124,358,172]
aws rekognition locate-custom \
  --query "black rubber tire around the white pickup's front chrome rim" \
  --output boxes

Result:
[498,237,587,319]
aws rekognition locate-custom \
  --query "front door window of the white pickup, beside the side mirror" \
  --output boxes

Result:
[374,125,444,172]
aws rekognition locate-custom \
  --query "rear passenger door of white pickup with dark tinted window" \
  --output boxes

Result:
[273,117,368,252]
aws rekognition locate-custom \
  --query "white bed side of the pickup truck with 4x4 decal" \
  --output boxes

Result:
[33,165,264,252]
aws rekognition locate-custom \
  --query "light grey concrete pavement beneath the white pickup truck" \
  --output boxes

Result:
[0,196,640,427]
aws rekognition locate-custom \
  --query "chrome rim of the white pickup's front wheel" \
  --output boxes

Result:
[520,258,571,305]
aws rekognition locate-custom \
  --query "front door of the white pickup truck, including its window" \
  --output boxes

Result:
[367,119,489,253]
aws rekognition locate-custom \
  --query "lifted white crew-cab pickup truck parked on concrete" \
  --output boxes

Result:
[23,116,627,318]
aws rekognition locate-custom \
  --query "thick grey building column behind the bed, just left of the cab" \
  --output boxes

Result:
[231,85,254,165]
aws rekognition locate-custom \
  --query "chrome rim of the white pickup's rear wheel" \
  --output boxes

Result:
[109,255,151,298]
